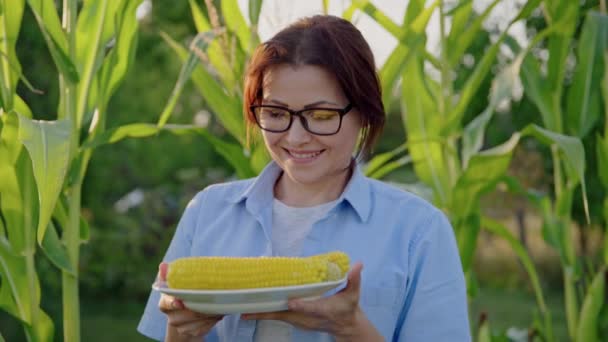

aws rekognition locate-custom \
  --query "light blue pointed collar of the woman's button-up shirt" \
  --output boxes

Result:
[230,161,371,222]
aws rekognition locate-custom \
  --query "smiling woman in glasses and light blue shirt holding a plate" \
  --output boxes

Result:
[139,16,470,341]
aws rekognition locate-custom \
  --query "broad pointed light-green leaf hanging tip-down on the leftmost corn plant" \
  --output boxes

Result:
[19,116,72,243]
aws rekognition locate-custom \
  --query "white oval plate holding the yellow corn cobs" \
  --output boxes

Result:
[152,276,346,314]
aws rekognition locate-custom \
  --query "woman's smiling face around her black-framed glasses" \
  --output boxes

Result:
[262,64,361,189]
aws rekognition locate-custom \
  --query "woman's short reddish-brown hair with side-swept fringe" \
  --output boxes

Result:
[243,15,385,155]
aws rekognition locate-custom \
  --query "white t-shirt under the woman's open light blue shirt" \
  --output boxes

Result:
[253,198,337,342]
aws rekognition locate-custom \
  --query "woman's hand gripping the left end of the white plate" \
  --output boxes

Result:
[158,262,224,342]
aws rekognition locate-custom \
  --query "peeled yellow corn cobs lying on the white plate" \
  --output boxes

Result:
[167,252,348,290]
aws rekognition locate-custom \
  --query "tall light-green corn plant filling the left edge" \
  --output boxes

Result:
[0,0,141,341]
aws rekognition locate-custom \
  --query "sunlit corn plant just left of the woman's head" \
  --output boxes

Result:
[158,0,269,178]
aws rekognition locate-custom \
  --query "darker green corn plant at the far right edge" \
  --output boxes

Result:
[510,1,608,341]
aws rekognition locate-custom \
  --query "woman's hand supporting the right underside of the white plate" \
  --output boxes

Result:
[241,263,383,341]
